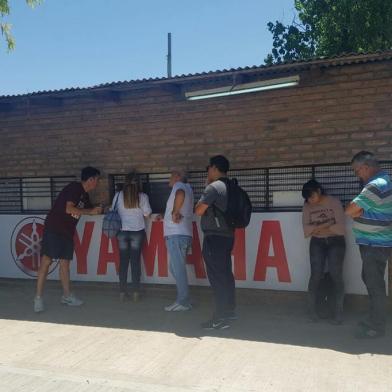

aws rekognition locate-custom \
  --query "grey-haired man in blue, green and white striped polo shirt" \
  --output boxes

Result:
[346,151,392,338]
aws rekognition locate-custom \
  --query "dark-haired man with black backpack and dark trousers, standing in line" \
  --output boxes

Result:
[195,155,252,329]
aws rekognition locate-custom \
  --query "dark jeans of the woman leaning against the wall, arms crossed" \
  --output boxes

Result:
[308,236,346,317]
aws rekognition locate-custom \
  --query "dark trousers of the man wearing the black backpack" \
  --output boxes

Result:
[203,235,235,318]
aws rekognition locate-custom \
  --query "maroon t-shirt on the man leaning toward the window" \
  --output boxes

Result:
[45,182,91,239]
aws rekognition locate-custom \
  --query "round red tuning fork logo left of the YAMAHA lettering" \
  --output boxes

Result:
[11,216,57,277]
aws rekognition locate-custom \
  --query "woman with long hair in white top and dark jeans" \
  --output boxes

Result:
[112,173,151,301]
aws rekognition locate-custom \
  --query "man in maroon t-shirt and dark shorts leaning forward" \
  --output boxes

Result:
[34,167,102,312]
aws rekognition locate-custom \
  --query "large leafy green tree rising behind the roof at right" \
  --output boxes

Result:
[265,0,392,64]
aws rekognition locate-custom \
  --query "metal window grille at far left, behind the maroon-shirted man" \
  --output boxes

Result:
[0,176,76,214]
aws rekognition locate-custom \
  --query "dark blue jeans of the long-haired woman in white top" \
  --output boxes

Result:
[117,230,146,293]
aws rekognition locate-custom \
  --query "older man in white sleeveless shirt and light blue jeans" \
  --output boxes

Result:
[163,170,193,312]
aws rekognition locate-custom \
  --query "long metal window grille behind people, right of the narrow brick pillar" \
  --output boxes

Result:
[109,161,392,213]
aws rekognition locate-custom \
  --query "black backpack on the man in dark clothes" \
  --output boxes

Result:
[220,177,252,228]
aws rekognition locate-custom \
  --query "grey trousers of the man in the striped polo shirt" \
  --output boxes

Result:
[359,245,391,332]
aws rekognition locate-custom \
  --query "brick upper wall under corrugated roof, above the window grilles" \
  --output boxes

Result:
[0,51,392,290]
